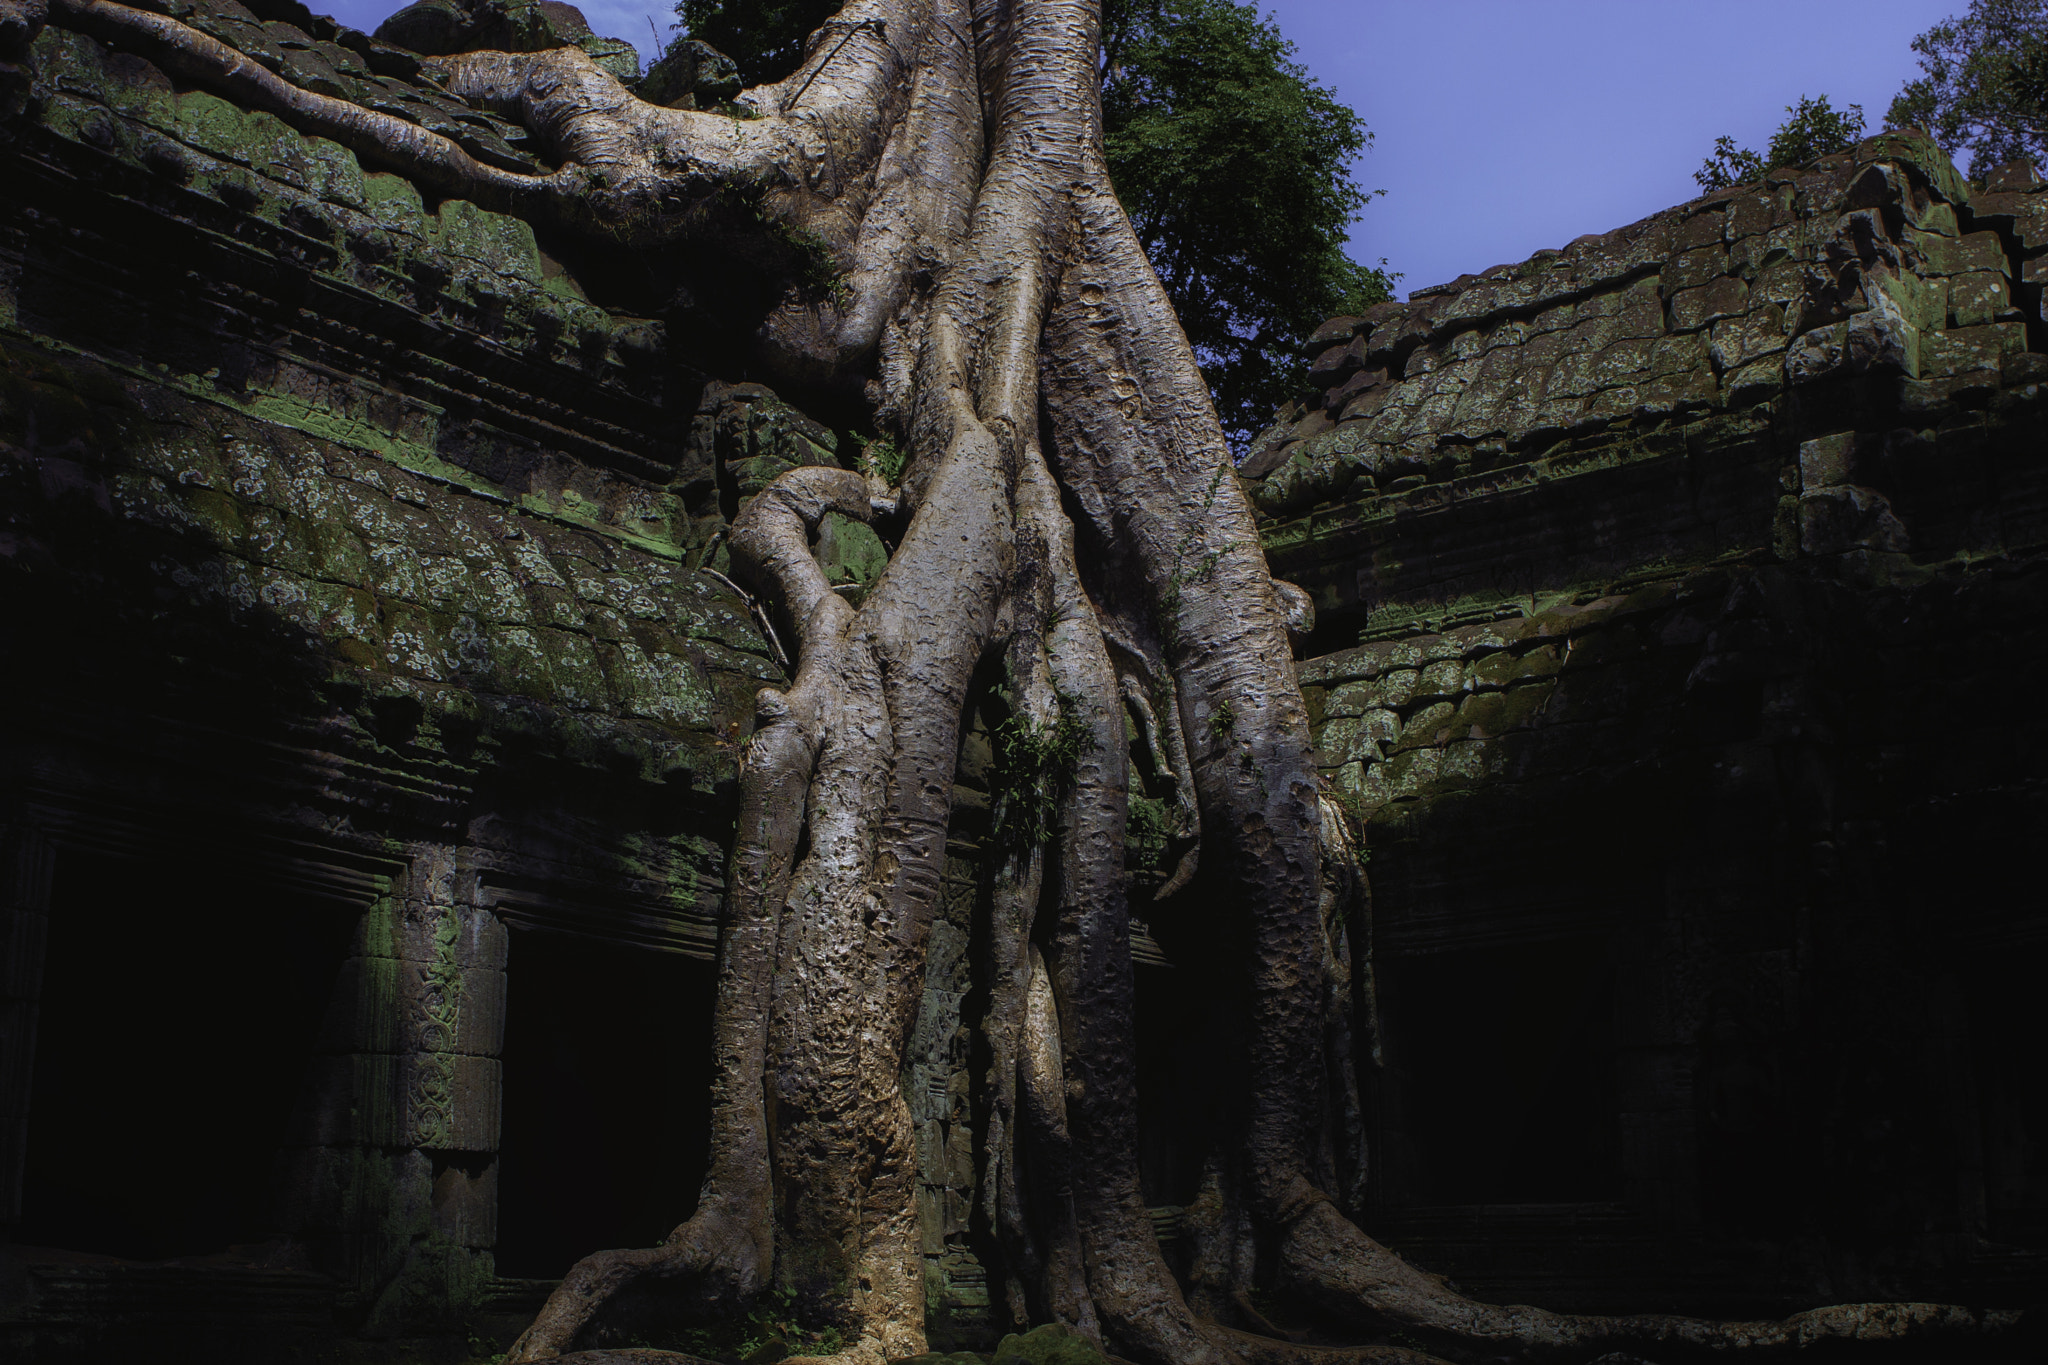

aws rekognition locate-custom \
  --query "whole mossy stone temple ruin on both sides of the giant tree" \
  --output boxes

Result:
[0,0,2048,1365]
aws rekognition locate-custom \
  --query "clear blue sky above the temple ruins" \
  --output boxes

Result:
[311,0,1968,291]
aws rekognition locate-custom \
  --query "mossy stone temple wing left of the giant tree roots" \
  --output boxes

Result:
[0,2,798,1359]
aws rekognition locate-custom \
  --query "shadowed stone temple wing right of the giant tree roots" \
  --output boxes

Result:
[1241,135,2048,1308]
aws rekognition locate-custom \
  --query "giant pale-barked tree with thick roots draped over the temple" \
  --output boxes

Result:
[8,0,2023,1365]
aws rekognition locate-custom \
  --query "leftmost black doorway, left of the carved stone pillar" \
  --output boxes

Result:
[16,849,350,1261]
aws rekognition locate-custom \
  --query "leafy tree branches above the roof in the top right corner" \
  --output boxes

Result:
[1884,0,2048,176]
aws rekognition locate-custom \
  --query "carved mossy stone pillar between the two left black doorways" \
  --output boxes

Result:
[287,845,506,1334]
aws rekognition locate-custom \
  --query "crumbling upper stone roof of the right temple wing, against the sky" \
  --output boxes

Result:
[1239,133,2048,520]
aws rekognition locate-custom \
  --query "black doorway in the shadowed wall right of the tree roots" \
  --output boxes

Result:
[1380,939,1620,1203]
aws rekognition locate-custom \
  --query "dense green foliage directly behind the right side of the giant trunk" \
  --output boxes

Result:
[1102,0,1399,448]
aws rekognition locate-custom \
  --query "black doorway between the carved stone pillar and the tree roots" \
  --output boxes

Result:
[498,931,713,1279]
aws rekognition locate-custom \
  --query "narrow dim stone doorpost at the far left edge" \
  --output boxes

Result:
[0,821,51,1240]
